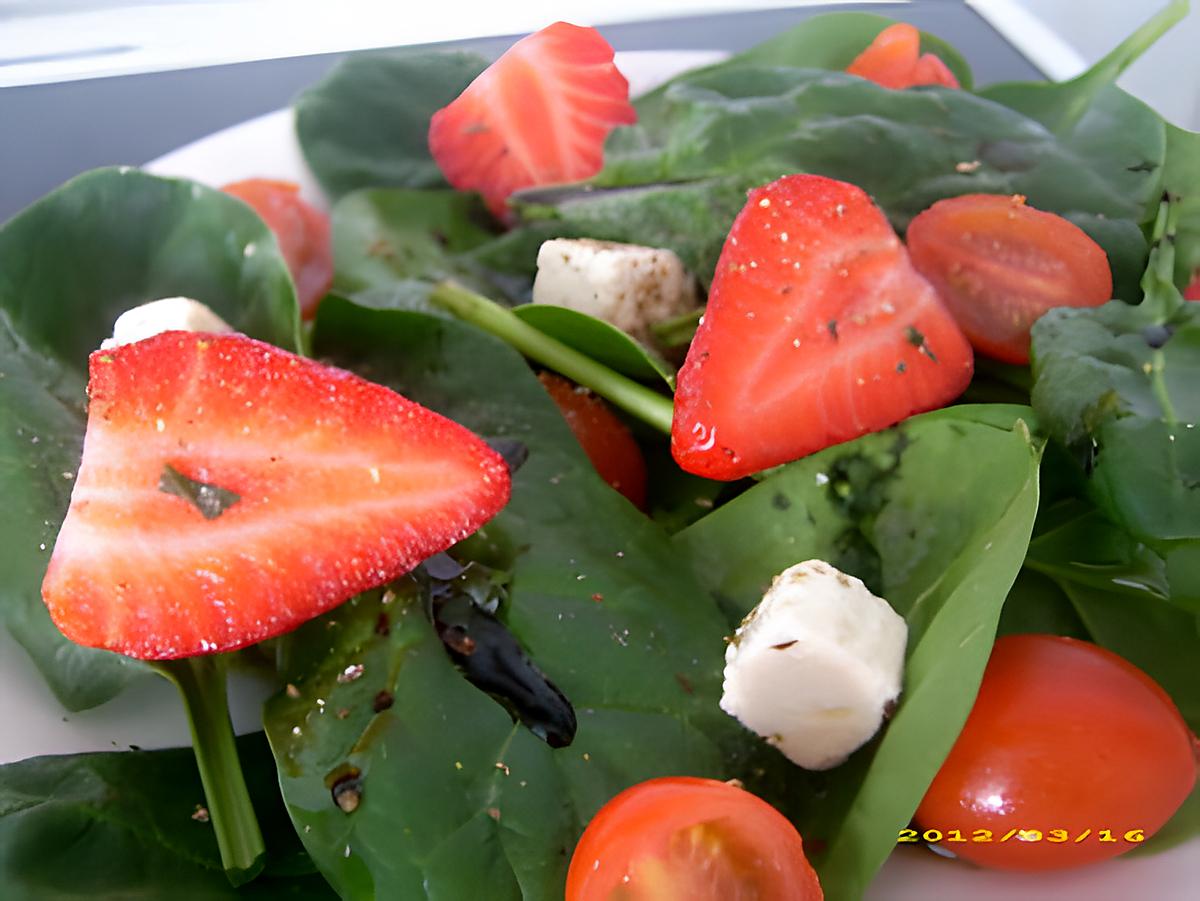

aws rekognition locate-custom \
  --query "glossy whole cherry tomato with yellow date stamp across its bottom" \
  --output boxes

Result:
[916,635,1196,871]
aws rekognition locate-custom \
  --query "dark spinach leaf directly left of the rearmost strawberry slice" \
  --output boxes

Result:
[295,50,487,200]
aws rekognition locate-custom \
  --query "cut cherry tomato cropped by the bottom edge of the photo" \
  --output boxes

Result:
[566,776,824,901]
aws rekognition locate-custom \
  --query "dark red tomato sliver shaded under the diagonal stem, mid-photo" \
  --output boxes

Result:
[538,372,646,509]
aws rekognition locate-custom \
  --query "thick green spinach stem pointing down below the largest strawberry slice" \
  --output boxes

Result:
[155,656,266,885]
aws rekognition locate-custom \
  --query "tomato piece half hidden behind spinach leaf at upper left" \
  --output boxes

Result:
[221,179,334,319]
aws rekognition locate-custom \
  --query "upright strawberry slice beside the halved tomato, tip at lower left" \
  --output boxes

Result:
[671,175,973,487]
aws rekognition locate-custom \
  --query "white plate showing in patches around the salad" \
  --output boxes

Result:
[0,50,1200,901]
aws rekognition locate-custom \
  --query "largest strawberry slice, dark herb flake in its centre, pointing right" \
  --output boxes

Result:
[42,331,509,659]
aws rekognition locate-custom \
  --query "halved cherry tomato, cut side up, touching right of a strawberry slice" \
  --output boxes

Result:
[907,194,1112,364]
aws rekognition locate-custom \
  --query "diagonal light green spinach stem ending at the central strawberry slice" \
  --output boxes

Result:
[430,282,673,434]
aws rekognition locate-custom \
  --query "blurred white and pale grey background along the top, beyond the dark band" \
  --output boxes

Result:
[0,0,1200,128]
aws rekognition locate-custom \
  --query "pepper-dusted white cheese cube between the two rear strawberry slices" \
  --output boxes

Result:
[533,238,697,344]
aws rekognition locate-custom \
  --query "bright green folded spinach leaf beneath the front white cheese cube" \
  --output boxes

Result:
[676,406,1040,899]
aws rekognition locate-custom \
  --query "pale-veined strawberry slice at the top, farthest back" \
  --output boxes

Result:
[430,22,637,216]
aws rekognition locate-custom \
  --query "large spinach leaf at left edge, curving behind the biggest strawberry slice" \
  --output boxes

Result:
[0,169,300,710]
